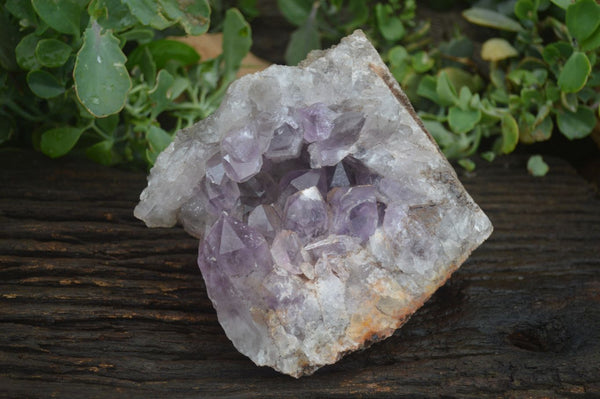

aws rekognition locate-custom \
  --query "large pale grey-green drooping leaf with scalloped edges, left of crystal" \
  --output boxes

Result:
[73,22,131,118]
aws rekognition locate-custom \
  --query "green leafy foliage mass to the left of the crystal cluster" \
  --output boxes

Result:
[0,0,252,165]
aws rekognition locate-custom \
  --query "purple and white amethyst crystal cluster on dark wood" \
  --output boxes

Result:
[135,31,492,377]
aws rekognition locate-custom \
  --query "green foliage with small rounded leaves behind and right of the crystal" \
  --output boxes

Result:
[278,0,600,176]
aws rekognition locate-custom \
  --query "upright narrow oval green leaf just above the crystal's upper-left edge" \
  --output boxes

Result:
[223,8,252,80]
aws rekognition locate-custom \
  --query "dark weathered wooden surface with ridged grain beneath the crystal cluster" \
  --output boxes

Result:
[0,152,600,398]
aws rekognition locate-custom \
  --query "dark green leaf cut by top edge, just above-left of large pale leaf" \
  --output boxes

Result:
[31,0,82,36]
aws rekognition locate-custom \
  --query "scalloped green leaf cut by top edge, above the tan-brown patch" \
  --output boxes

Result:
[158,0,210,36]
